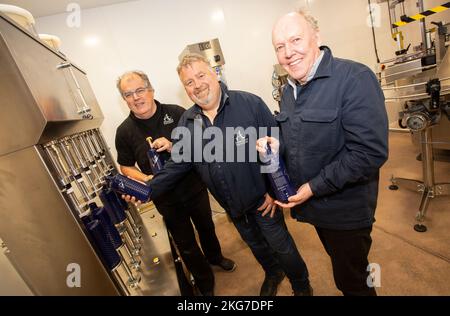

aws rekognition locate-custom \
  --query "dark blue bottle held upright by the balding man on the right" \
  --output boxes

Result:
[265,144,297,203]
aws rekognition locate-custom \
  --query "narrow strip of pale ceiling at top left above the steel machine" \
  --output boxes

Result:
[0,0,131,18]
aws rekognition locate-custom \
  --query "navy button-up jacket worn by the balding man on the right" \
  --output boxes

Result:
[276,47,388,230]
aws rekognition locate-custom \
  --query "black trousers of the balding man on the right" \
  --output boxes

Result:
[316,226,377,296]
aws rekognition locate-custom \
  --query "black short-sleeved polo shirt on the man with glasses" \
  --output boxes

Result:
[115,100,205,207]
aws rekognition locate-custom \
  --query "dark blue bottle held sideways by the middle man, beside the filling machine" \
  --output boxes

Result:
[107,174,152,203]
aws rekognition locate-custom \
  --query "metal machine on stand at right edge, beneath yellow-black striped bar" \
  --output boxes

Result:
[378,0,450,232]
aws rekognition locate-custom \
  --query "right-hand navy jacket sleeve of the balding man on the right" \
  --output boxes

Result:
[309,69,388,197]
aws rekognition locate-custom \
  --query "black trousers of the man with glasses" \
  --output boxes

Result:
[158,189,223,292]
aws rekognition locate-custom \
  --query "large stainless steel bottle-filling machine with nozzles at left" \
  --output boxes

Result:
[0,13,181,295]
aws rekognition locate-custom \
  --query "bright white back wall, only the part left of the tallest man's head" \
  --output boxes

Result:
[36,0,295,159]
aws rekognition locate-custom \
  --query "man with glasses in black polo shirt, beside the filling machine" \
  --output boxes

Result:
[116,71,236,296]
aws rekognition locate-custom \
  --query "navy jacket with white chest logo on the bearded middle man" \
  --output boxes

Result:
[149,85,277,217]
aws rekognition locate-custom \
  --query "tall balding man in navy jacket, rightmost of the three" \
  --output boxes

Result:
[258,12,388,295]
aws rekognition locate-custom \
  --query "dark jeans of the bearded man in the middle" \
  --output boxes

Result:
[232,209,309,290]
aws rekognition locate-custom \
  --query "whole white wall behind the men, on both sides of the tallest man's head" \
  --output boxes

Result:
[37,0,446,162]
